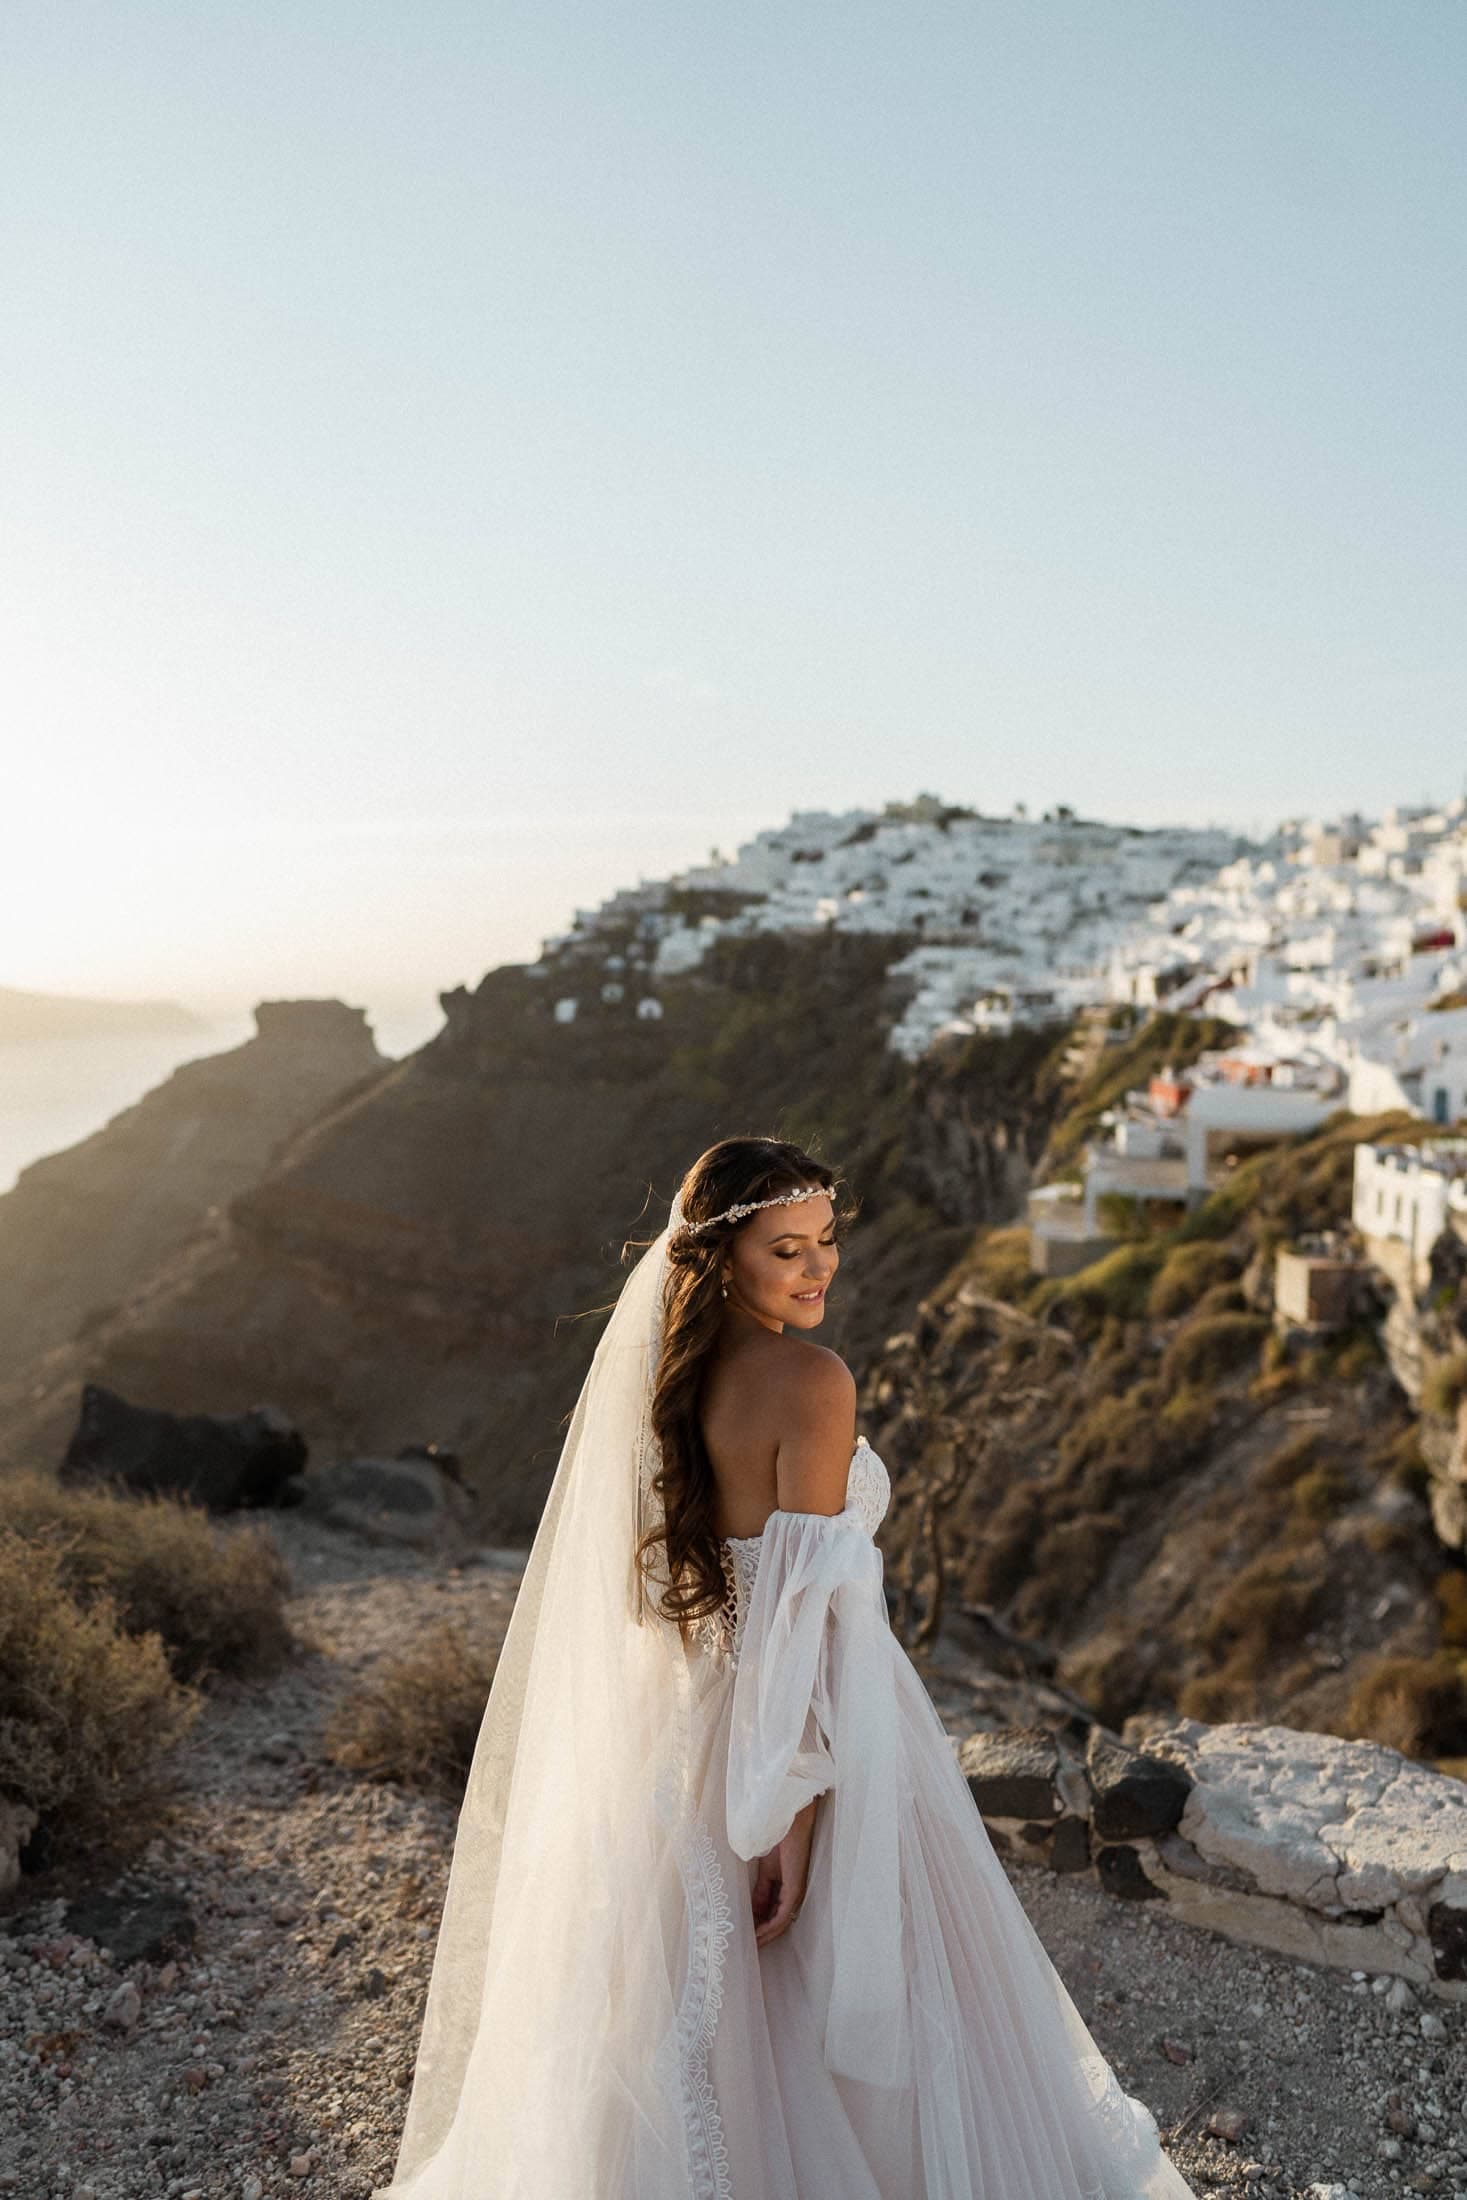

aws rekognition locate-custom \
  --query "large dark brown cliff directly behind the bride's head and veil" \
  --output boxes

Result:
[4,933,1068,1540]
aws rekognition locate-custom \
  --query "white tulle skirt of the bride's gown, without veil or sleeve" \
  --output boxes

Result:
[688,1635,1192,2200]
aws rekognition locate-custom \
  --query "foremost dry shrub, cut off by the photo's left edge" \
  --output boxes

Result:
[0,1529,200,1861]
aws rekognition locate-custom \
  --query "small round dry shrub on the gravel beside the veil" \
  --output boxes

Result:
[326,1621,495,1802]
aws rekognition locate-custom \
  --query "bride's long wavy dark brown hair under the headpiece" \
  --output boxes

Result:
[636,1137,851,1632]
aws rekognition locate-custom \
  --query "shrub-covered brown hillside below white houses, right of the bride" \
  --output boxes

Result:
[864,1118,1467,1758]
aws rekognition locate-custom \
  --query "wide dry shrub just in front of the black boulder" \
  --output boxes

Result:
[0,1472,290,1681]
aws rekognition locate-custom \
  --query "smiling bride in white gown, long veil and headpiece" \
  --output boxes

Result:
[372,1137,1190,2200]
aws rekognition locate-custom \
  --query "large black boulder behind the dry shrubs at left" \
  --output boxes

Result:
[62,1382,306,1511]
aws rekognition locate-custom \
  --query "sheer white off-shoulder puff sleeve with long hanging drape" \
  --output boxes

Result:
[728,1507,911,2086]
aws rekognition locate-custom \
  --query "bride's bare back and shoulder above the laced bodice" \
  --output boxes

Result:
[699,1329,856,1536]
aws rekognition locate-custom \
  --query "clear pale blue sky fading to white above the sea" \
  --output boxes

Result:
[0,0,1467,1034]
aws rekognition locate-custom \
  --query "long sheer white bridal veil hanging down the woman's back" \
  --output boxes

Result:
[374,1208,710,2200]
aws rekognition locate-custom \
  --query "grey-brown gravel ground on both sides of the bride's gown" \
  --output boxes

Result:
[0,1514,1467,2200]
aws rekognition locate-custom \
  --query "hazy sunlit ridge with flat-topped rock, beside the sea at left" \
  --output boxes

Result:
[0,1001,389,1395]
